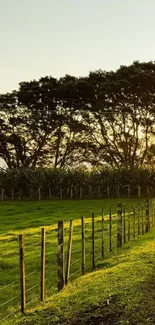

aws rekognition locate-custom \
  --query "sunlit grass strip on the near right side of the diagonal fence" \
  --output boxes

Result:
[4,225,155,325]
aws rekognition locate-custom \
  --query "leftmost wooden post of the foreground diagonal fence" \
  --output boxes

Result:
[19,235,26,313]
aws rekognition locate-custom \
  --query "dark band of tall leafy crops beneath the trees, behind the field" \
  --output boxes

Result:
[0,168,155,199]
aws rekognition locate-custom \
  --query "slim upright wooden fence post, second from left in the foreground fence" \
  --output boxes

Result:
[41,228,45,301]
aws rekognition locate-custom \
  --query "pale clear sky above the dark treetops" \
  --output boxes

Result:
[0,0,155,93]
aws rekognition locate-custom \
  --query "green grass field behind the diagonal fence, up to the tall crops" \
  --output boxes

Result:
[0,199,153,324]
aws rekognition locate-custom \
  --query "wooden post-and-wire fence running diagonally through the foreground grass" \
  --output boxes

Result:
[0,199,155,323]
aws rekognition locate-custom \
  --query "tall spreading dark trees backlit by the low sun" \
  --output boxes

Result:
[0,62,155,170]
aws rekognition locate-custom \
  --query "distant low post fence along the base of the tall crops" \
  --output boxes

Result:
[0,184,155,201]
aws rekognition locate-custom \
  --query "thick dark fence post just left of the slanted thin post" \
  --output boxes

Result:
[58,221,64,292]
